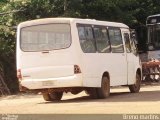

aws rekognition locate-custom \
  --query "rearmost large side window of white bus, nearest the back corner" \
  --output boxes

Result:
[78,26,96,53]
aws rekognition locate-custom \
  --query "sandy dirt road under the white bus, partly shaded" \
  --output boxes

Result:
[0,85,160,114]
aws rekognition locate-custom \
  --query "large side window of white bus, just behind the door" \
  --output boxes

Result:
[108,28,124,53]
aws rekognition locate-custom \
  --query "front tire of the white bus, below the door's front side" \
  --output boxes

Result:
[129,73,141,93]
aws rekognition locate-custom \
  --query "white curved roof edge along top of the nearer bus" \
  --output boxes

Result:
[19,18,129,28]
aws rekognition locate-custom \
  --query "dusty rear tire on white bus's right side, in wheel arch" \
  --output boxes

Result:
[97,76,110,99]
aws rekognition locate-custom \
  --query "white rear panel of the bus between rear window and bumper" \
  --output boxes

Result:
[20,50,74,79]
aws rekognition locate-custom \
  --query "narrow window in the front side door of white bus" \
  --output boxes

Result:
[123,33,132,53]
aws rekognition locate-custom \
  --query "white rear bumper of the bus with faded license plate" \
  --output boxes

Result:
[20,74,83,90]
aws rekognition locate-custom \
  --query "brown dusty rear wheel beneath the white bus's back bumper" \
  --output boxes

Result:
[42,92,63,101]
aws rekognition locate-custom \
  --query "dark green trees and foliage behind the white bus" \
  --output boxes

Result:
[0,0,160,95]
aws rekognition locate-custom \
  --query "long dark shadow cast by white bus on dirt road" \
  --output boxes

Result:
[39,91,160,104]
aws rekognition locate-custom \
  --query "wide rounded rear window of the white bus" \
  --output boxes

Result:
[20,24,71,52]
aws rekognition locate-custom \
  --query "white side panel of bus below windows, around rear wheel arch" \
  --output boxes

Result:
[82,53,127,87]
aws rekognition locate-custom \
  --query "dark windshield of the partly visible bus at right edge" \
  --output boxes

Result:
[148,24,160,50]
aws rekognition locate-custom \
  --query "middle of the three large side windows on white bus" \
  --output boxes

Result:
[94,27,111,53]
